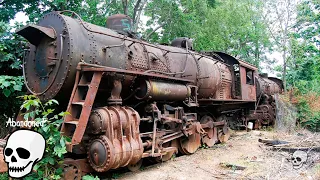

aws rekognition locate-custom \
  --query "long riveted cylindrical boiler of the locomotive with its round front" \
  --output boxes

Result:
[16,12,242,100]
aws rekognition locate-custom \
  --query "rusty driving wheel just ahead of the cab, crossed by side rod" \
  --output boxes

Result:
[200,115,218,147]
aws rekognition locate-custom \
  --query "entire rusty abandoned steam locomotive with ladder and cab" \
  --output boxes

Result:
[13,11,283,177]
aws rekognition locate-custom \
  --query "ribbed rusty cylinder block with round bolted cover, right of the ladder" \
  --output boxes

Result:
[88,106,143,172]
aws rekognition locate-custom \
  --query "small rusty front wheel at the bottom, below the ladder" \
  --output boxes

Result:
[63,158,82,180]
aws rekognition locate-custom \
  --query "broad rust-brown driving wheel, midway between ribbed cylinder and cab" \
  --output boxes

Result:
[179,132,201,155]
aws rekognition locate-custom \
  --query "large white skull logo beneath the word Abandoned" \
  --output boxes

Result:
[3,130,45,178]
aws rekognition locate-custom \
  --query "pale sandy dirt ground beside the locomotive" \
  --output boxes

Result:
[113,131,320,180]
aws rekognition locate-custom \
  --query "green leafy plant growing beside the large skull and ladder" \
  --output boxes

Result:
[21,95,71,180]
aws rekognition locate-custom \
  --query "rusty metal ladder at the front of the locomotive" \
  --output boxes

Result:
[60,69,103,152]
